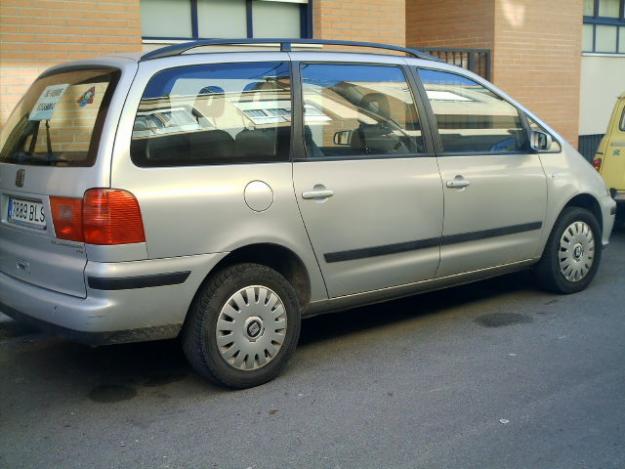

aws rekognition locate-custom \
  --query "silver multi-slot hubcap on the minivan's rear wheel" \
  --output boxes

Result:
[216,285,287,371]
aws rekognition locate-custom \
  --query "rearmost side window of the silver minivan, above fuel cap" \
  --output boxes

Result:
[131,63,291,166]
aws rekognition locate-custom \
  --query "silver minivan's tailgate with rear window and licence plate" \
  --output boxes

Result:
[0,68,119,297]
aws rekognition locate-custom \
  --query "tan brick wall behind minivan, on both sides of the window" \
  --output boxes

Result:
[0,0,582,142]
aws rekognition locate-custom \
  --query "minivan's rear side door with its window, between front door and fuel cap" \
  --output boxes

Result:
[293,60,443,298]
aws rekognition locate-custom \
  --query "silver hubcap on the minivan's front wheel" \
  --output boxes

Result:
[559,221,595,282]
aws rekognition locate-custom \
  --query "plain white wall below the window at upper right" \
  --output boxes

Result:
[579,55,625,135]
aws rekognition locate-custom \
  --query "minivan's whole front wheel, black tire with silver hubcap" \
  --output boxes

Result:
[534,207,602,294]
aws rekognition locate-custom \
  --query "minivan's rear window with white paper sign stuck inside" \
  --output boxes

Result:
[0,68,119,166]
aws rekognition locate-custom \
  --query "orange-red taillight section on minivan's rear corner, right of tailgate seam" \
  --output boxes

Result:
[82,189,145,244]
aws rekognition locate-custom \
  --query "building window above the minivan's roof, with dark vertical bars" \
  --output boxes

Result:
[141,0,312,40]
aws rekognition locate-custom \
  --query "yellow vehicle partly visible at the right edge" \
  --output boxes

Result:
[601,99,625,191]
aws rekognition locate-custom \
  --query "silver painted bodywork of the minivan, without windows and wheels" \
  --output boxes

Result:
[0,51,615,344]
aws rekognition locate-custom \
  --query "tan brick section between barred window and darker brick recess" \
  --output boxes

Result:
[313,0,406,46]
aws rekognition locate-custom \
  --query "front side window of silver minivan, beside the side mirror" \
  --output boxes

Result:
[419,70,528,153]
